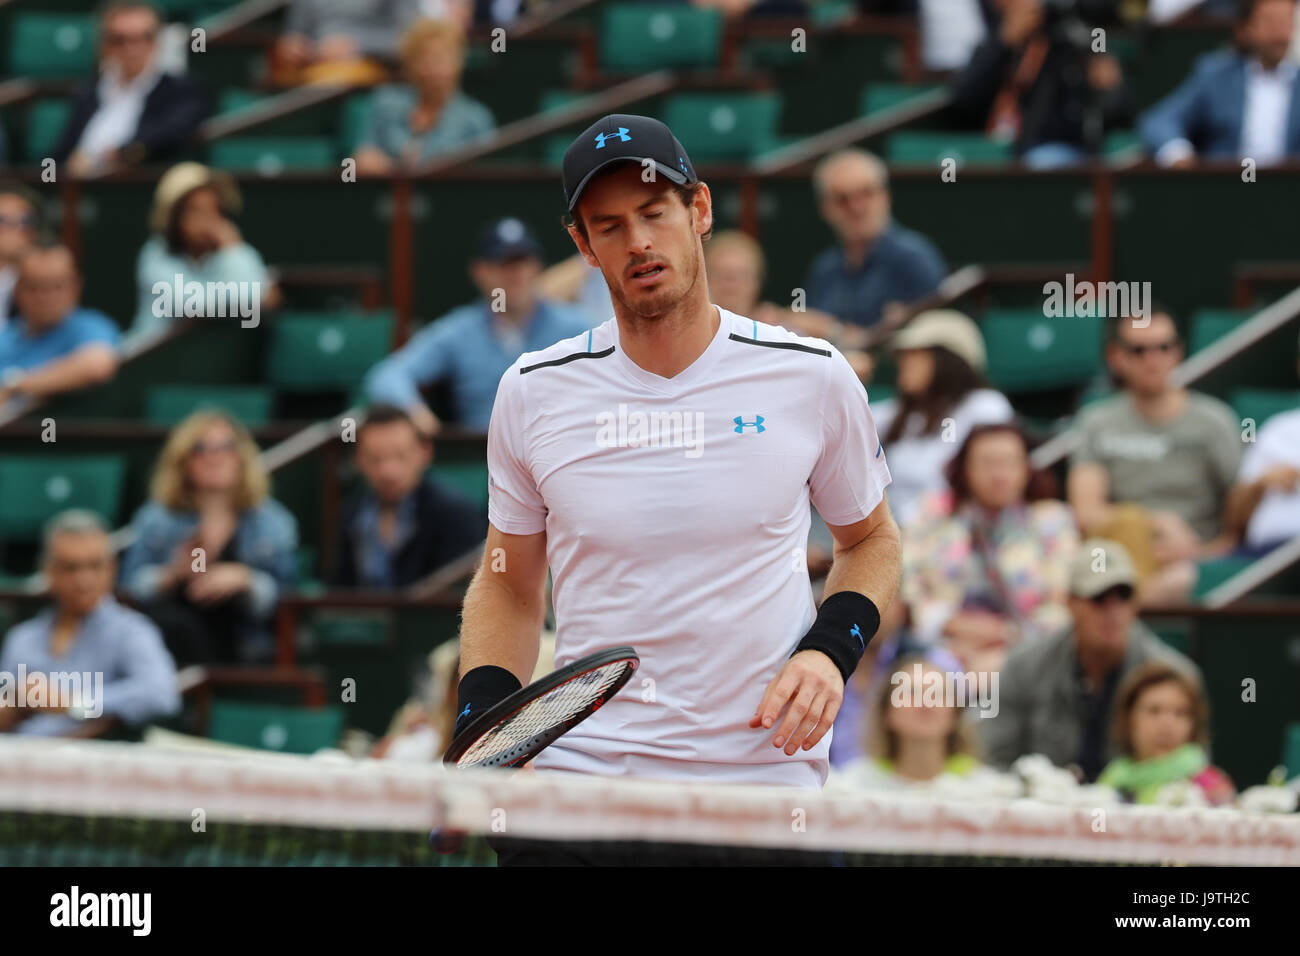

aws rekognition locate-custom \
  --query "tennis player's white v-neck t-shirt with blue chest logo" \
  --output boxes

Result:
[488,310,889,788]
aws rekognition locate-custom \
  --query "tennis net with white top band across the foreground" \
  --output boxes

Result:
[0,737,1300,866]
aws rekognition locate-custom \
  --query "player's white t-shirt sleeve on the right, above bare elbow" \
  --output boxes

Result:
[809,349,891,525]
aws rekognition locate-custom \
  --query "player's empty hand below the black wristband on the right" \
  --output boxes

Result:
[749,650,844,757]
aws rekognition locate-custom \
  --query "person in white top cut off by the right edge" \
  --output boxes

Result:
[1225,340,1300,555]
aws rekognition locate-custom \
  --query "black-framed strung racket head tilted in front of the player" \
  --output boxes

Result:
[442,645,641,770]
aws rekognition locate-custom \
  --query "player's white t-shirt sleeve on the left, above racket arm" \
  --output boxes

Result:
[488,363,546,535]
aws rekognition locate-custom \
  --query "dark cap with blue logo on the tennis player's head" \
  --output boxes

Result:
[564,113,699,212]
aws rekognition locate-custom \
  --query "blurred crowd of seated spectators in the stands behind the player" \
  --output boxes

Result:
[0,0,1300,805]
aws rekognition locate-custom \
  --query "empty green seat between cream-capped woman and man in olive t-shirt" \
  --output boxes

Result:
[980,310,1105,393]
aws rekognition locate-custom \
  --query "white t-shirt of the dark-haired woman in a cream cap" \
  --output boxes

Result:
[876,389,1015,525]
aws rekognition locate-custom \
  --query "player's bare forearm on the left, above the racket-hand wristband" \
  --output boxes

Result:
[460,528,546,684]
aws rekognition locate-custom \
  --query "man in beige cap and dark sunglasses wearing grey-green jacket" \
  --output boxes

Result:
[979,538,1199,783]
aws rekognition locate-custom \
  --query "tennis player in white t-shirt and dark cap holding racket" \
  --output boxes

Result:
[458,114,900,863]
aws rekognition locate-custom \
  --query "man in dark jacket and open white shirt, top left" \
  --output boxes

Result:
[53,0,208,176]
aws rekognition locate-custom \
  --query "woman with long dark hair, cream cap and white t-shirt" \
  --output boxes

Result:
[875,310,1015,527]
